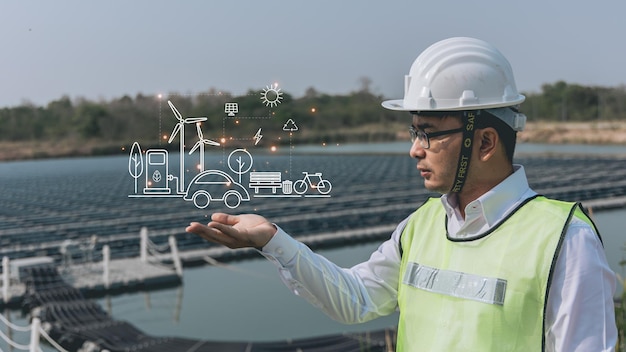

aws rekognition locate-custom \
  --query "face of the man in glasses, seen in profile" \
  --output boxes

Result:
[410,115,463,194]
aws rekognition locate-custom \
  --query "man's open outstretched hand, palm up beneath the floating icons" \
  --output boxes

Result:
[186,213,276,248]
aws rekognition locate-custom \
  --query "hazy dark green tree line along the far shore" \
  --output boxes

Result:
[0,81,626,148]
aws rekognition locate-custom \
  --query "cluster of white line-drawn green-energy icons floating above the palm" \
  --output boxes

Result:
[128,88,332,209]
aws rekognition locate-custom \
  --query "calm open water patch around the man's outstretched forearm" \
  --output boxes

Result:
[95,244,397,341]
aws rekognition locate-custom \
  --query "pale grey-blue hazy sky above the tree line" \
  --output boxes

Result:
[0,0,626,107]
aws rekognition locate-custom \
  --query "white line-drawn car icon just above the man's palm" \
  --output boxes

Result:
[183,170,250,209]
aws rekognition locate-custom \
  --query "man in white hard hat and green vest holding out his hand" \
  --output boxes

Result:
[187,38,617,351]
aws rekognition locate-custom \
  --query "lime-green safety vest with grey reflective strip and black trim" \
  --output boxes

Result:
[397,196,598,352]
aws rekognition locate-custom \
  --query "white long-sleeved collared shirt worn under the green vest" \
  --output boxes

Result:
[261,165,617,352]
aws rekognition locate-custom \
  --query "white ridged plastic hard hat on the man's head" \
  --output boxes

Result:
[382,37,526,131]
